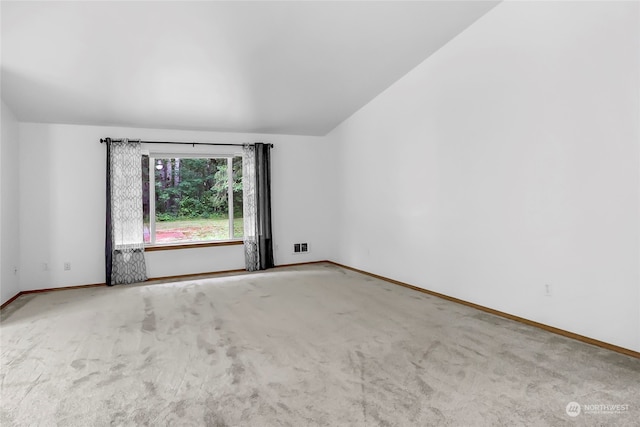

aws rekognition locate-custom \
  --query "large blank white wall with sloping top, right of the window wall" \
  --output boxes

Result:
[329,2,640,351]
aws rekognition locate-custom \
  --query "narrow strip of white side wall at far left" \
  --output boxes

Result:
[0,101,20,304]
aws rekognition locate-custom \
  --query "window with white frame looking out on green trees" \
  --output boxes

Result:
[142,154,243,245]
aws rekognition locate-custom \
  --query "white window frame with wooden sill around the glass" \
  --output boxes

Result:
[142,149,244,251]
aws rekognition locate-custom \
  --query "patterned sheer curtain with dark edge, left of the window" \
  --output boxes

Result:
[105,139,147,285]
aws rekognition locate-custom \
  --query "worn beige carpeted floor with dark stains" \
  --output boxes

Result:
[0,264,640,426]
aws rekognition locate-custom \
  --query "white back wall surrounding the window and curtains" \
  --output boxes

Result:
[20,123,337,290]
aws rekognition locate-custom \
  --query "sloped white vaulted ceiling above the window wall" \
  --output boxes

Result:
[1,1,498,135]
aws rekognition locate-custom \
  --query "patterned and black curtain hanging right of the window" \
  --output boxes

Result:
[242,143,274,271]
